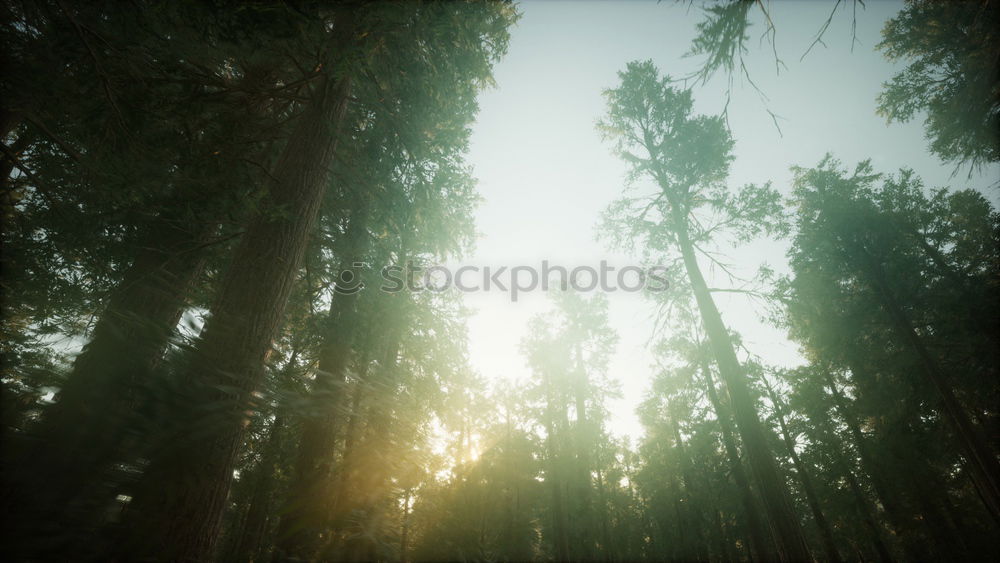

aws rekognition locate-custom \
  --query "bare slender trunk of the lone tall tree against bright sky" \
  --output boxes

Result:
[677,225,811,561]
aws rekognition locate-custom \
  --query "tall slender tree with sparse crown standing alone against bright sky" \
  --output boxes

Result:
[599,61,810,561]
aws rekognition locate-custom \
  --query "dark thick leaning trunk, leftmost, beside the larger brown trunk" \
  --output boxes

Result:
[7,213,215,551]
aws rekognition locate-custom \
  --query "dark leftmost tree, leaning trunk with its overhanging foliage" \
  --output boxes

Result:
[4,2,298,553]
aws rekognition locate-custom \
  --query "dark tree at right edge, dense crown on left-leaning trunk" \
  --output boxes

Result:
[793,159,1000,519]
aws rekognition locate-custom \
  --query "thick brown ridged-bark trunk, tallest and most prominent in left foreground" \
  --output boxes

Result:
[119,15,354,561]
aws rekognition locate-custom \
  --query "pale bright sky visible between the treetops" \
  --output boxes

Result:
[465,1,1000,437]
